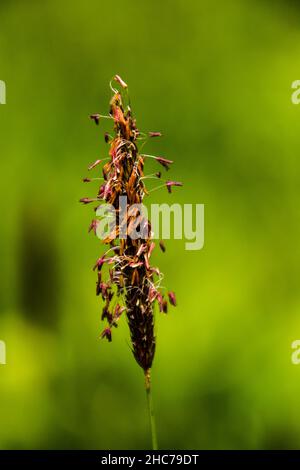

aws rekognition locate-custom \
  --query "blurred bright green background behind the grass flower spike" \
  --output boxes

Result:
[0,0,300,449]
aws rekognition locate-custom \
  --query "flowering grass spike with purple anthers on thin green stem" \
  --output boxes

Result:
[80,75,182,448]
